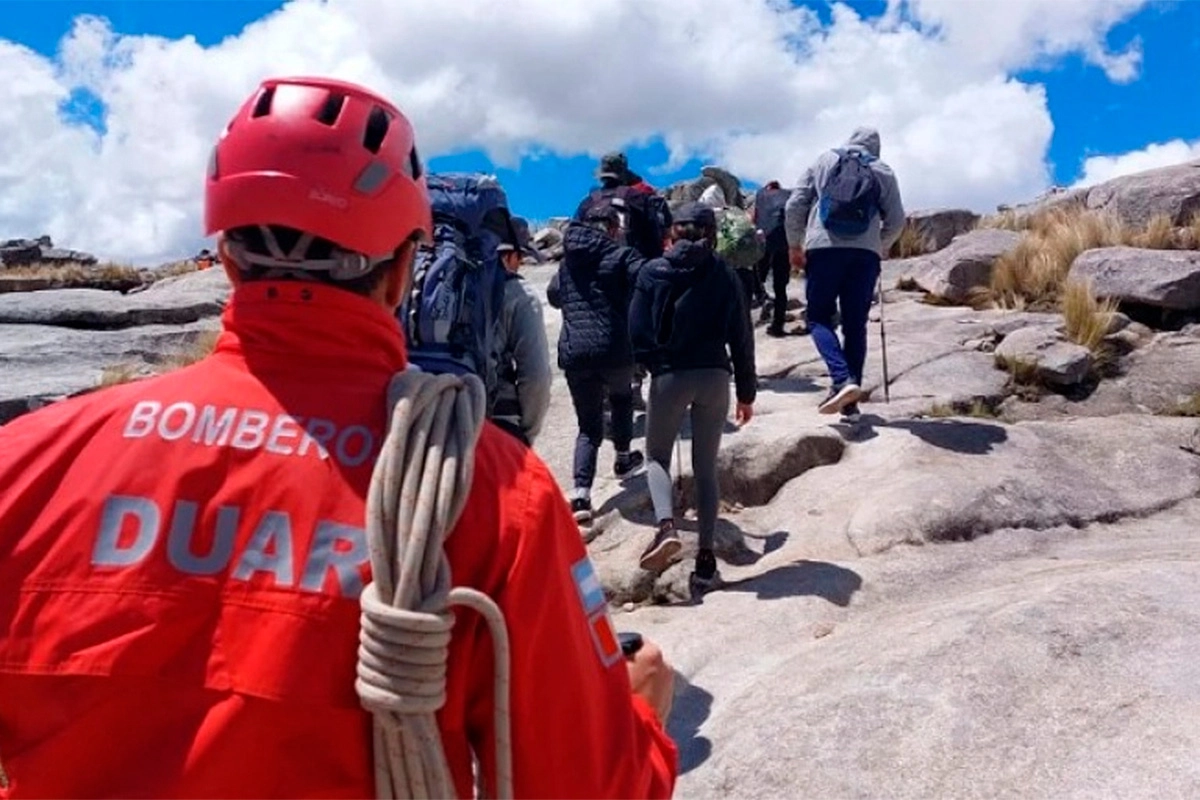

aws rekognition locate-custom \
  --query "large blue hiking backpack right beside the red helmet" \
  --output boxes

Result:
[398,173,517,397]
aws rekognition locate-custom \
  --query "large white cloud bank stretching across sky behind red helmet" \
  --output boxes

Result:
[0,0,1148,263]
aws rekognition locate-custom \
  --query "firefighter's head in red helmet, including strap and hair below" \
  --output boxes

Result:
[204,78,433,307]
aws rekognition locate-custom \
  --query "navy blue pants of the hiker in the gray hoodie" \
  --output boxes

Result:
[805,247,880,386]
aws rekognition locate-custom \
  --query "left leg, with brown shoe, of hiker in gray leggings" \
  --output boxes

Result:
[641,372,692,572]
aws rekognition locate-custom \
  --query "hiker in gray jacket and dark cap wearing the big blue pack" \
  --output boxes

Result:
[491,227,552,445]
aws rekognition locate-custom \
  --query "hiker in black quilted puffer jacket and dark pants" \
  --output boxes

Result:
[546,201,646,524]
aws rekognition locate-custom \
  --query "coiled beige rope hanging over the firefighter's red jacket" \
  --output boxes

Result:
[355,369,512,800]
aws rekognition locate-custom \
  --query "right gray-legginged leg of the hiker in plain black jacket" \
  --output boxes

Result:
[691,369,730,551]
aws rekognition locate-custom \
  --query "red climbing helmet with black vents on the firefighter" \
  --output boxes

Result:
[204,78,433,259]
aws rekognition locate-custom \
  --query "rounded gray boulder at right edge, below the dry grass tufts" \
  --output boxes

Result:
[1070,247,1200,311]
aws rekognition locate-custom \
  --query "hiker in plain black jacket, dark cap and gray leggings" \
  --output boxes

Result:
[629,203,757,584]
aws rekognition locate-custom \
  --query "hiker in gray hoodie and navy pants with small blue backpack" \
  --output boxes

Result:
[785,127,905,420]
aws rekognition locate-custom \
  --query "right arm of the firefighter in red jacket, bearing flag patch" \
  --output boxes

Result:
[473,453,678,798]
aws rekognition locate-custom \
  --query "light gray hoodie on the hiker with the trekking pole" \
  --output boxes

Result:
[784,127,905,257]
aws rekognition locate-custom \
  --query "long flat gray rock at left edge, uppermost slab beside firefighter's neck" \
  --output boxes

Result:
[0,270,230,330]
